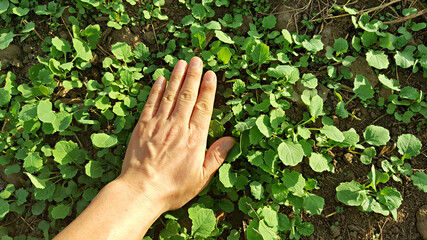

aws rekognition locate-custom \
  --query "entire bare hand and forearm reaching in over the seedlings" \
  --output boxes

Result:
[54,57,234,240]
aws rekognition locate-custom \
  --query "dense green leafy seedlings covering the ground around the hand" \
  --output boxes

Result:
[0,0,427,240]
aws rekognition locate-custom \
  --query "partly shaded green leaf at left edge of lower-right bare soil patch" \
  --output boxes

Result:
[336,181,368,206]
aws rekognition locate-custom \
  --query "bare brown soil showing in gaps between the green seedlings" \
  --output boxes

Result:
[0,0,427,240]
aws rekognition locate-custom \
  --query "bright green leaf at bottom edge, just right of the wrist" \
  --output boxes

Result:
[188,204,217,238]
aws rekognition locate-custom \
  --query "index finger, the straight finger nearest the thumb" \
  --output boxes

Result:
[190,71,216,133]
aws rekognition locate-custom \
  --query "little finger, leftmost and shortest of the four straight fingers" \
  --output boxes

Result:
[140,76,166,121]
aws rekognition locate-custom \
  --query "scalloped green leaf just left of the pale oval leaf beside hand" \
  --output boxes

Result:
[52,140,81,165]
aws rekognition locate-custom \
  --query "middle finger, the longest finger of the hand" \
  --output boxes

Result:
[172,57,203,121]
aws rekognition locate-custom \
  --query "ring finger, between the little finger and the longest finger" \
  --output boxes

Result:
[157,60,187,118]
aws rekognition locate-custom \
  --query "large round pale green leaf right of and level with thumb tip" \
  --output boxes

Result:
[277,140,304,166]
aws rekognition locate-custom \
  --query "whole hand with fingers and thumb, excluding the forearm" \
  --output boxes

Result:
[117,57,234,211]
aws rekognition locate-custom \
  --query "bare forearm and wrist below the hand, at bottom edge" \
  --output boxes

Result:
[54,180,163,240]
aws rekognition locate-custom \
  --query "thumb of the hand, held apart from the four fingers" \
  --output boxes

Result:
[203,137,234,176]
